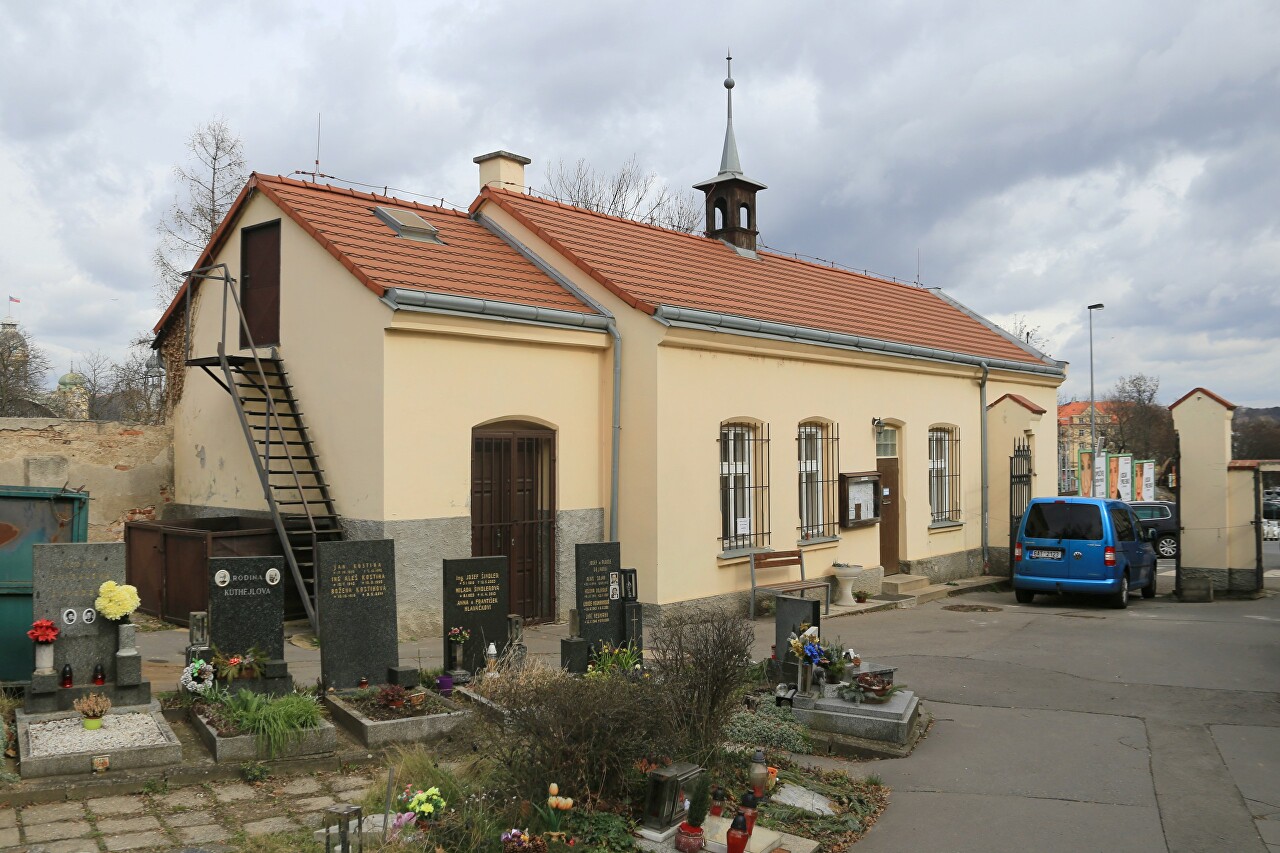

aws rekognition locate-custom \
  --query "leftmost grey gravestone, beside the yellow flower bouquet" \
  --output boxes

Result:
[26,542,151,712]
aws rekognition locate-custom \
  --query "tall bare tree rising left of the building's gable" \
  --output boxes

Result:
[152,118,247,306]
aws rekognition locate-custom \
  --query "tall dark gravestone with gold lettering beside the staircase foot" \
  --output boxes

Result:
[316,539,394,690]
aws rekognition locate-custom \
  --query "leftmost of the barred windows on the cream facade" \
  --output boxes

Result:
[719,424,769,551]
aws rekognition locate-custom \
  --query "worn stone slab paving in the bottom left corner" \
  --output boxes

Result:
[0,771,375,853]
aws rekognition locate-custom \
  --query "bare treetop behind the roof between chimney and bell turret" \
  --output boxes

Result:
[545,155,703,233]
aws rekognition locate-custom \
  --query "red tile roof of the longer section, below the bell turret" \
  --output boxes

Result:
[481,187,1044,364]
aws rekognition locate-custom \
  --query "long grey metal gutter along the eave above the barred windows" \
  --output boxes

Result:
[654,305,1066,377]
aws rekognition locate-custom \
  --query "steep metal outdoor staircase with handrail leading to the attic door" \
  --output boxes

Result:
[187,265,344,630]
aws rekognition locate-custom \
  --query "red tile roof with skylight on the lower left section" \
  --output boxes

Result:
[156,173,595,330]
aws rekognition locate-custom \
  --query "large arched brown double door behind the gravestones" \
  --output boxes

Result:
[471,428,556,622]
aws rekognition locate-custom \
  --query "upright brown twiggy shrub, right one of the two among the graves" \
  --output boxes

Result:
[648,607,755,763]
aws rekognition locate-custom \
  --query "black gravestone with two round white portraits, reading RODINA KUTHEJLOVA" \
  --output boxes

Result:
[209,557,284,661]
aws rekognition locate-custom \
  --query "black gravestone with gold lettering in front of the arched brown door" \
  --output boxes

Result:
[443,557,511,672]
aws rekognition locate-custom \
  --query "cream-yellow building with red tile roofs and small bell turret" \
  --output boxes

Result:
[157,96,1065,635]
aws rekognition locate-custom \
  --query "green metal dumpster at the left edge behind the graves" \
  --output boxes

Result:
[0,485,88,684]
